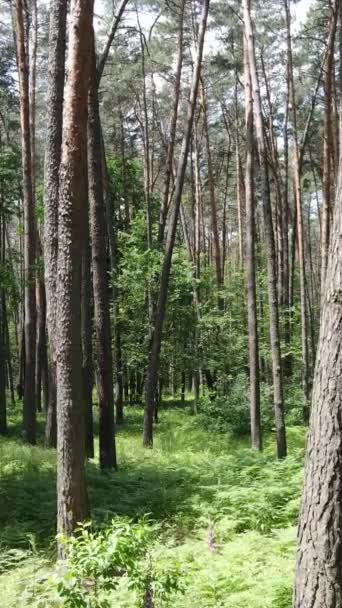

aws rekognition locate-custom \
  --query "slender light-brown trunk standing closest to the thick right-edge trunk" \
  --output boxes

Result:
[284,0,311,422]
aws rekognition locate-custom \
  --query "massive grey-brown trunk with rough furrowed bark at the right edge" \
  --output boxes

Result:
[294,138,342,608]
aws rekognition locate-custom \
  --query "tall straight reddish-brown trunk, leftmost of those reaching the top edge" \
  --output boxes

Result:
[16,0,36,444]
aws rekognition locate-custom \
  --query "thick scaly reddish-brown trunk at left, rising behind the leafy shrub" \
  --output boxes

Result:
[57,0,93,544]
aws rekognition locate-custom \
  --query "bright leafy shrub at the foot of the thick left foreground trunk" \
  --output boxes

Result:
[56,520,184,608]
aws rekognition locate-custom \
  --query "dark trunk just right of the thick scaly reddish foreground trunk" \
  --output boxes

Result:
[88,33,116,469]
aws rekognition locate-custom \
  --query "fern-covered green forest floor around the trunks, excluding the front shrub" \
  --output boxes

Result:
[0,405,305,608]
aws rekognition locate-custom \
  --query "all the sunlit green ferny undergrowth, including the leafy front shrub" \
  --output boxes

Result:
[0,406,304,608]
